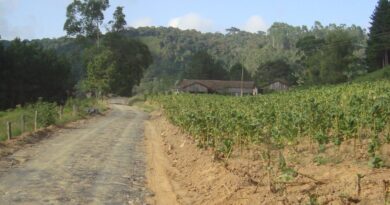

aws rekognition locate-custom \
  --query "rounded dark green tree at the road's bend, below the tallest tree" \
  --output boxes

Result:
[82,33,153,96]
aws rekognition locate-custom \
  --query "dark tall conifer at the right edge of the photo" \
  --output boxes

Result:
[366,0,390,71]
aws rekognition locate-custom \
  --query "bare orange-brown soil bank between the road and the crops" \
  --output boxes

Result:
[145,111,390,205]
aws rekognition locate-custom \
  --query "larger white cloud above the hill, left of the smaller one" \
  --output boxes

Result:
[168,13,213,32]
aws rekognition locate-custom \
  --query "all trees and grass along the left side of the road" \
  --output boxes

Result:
[0,0,152,144]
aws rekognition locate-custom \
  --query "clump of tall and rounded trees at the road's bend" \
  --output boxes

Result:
[64,0,152,97]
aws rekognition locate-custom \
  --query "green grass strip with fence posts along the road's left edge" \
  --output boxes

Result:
[0,99,107,141]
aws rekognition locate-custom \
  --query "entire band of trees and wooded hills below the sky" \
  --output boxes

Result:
[1,0,390,108]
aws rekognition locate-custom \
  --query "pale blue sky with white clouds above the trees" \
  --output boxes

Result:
[0,0,377,40]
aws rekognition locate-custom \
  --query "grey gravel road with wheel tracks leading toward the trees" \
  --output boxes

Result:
[0,105,148,205]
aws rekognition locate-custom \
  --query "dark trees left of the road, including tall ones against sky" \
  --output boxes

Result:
[0,0,153,110]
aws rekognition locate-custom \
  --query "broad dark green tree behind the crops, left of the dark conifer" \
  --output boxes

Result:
[297,26,361,84]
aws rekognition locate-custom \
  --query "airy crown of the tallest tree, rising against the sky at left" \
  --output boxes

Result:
[64,0,110,44]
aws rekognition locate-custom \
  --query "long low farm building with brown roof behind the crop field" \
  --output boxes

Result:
[178,79,255,95]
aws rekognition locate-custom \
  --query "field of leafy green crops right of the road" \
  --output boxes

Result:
[152,81,390,168]
